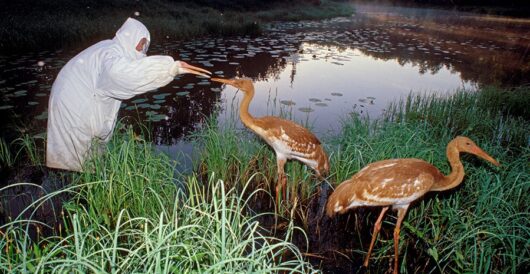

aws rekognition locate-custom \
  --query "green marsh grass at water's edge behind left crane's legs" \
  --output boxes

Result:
[190,114,319,213]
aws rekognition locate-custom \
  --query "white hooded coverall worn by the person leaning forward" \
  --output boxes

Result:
[46,18,174,171]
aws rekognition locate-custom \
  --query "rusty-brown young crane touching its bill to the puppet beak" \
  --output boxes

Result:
[211,78,329,206]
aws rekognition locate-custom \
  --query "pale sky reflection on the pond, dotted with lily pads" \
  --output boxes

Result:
[217,43,473,135]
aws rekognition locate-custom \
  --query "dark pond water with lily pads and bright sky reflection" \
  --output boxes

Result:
[0,3,530,151]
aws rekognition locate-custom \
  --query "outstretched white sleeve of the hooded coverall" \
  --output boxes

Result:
[96,55,174,100]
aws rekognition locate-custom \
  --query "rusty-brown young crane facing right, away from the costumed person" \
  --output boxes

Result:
[326,136,499,273]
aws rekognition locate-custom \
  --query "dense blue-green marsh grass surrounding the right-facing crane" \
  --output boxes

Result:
[331,91,530,273]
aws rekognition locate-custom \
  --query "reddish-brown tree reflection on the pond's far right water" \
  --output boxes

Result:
[292,14,530,86]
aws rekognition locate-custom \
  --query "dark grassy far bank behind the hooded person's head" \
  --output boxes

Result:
[0,0,353,52]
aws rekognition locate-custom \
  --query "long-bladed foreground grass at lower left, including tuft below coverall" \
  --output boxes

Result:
[0,127,314,273]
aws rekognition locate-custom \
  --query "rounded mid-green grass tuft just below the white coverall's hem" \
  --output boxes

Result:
[77,129,177,225]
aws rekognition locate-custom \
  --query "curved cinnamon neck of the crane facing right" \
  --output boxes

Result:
[431,143,465,191]
